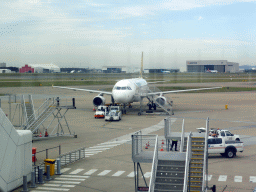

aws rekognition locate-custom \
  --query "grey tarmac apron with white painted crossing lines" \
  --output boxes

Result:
[0,85,256,192]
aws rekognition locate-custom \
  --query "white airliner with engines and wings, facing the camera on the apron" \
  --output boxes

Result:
[53,53,221,115]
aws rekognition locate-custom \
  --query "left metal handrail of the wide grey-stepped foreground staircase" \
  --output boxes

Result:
[148,135,158,192]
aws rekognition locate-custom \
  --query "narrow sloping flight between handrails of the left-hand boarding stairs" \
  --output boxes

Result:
[26,104,57,133]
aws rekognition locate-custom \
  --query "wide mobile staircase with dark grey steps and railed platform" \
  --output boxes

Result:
[132,130,191,192]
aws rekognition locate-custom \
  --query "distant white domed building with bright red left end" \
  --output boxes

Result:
[19,64,60,73]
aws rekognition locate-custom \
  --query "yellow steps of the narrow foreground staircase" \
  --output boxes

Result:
[183,137,205,192]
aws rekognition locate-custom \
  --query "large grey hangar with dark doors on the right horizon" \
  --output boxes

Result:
[186,60,239,73]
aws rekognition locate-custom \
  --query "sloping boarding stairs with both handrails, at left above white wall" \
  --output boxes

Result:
[23,98,57,133]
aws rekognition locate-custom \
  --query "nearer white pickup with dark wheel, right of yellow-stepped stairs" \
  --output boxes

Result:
[208,137,244,158]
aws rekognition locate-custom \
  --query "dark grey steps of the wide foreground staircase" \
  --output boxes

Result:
[154,160,185,192]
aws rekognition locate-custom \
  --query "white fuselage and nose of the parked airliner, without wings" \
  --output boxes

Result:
[112,78,150,103]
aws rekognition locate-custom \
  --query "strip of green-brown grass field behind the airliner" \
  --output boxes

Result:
[0,73,256,92]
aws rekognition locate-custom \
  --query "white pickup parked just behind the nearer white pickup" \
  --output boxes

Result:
[197,127,240,141]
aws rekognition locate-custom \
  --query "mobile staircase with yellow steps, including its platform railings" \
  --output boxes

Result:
[165,118,209,192]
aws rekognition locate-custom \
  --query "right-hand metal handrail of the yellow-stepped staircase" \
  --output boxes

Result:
[202,117,209,192]
